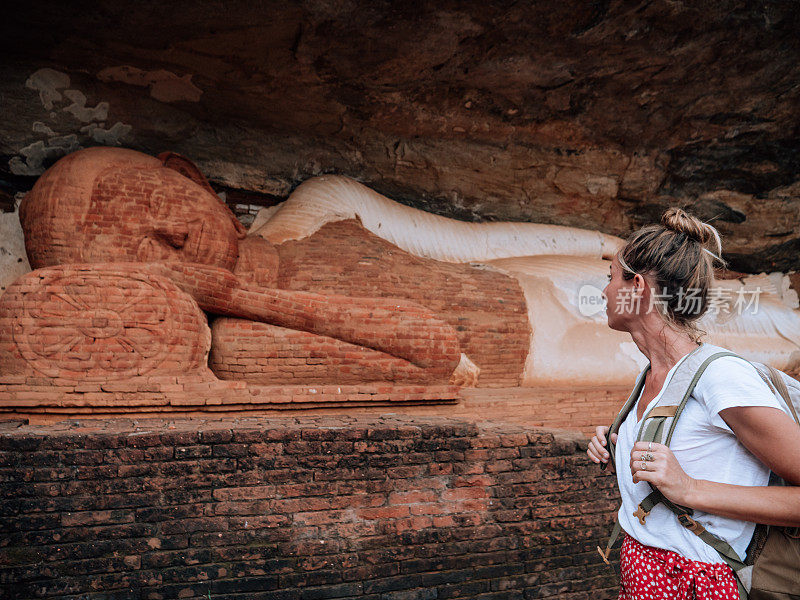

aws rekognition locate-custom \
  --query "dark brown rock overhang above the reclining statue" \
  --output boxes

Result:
[0,0,800,272]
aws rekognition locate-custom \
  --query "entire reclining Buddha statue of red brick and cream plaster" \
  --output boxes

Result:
[0,148,800,387]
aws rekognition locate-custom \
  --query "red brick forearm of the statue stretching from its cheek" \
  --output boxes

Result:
[148,263,460,371]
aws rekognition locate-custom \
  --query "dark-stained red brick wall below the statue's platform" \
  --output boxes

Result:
[0,416,616,600]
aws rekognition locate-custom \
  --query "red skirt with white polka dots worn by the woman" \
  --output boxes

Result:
[619,535,739,600]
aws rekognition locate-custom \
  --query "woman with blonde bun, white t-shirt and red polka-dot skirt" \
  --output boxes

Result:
[588,208,800,600]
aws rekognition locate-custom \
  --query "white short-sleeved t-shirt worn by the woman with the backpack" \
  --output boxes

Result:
[615,346,780,563]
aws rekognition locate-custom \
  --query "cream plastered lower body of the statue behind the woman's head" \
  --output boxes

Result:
[490,256,800,386]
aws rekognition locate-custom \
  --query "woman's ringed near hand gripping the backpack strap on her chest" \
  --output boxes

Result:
[631,442,697,506]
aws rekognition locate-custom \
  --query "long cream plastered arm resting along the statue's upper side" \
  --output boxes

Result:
[251,175,622,263]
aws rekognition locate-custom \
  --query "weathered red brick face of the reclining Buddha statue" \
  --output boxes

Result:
[81,167,239,270]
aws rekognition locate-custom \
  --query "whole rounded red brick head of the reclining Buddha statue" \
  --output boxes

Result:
[20,148,245,270]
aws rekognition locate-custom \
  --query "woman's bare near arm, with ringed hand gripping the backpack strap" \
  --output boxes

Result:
[631,406,800,526]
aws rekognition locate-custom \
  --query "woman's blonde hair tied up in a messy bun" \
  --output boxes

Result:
[617,207,725,341]
